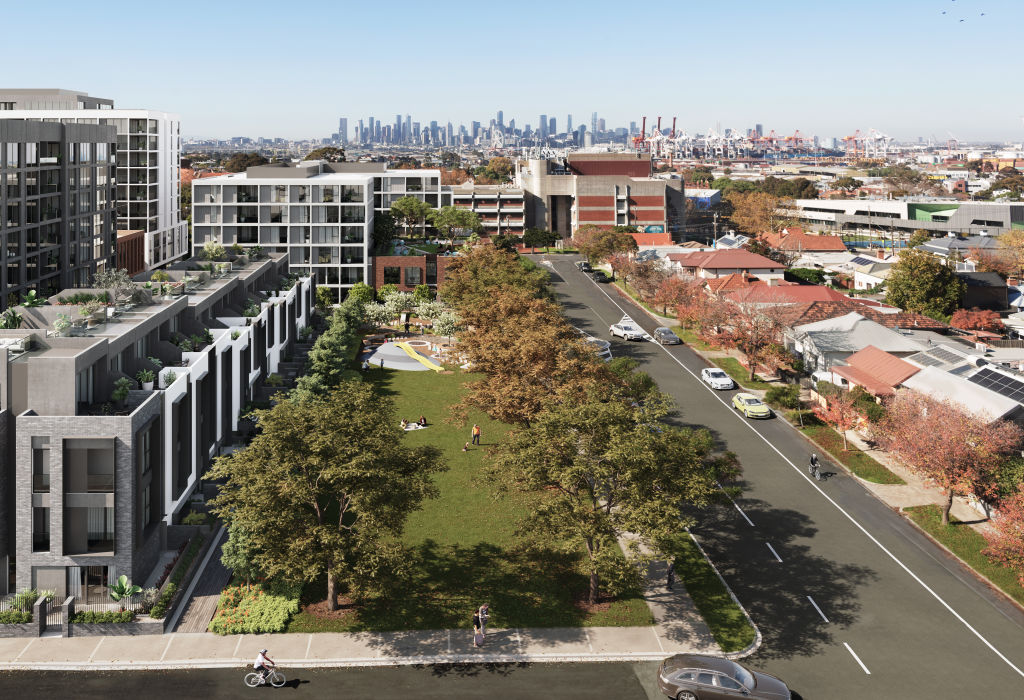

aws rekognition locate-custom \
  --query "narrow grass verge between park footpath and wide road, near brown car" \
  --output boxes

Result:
[676,538,755,652]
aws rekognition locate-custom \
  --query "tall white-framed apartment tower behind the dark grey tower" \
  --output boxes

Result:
[0,88,188,269]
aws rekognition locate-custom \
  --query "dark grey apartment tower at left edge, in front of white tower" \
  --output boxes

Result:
[0,120,117,310]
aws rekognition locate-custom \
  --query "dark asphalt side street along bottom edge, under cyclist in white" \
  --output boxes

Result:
[0,662,664,700]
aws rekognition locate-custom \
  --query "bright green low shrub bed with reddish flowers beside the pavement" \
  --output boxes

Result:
[209,583,301,635]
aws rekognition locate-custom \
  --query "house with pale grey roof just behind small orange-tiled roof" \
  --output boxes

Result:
[784,312,924,371]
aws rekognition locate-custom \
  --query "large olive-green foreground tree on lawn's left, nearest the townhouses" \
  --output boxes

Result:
[210,381,444,610]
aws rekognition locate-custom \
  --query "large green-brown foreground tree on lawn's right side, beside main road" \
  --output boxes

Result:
[489,395,718,604]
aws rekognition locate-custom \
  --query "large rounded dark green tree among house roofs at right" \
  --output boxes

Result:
[886,248,966,316]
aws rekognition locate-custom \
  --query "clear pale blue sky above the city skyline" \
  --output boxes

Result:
[0,0,1024,141]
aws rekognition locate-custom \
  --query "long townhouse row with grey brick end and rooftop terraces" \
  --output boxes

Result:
[0,254,313,603]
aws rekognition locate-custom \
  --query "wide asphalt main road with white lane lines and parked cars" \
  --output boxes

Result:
[537,256,1024,699]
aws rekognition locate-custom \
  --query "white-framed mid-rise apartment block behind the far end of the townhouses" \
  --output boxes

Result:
[193,161,451,302]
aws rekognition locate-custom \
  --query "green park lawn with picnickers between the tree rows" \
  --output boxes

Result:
[288,369,653,632]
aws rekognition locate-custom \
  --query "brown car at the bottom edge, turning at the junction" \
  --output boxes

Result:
[657,654,793,700]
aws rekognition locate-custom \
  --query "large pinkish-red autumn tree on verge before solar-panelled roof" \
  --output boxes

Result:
[876,390,1022,525]
